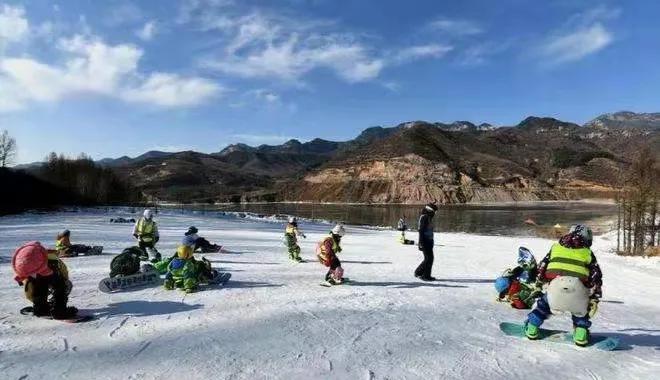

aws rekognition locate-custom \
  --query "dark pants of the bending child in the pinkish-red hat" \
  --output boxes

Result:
[25,274,71,316]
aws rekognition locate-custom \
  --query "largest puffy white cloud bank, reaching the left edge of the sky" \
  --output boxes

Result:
[0,35,222,111]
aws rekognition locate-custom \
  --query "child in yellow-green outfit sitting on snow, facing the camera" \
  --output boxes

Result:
[164,244,217,293]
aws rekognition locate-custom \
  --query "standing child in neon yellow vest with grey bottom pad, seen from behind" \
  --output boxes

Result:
[525,224,603,346]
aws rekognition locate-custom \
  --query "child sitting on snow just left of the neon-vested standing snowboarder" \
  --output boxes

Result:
[495,247,539,309]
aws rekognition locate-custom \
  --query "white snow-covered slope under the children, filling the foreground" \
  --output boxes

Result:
[0,212,660,379]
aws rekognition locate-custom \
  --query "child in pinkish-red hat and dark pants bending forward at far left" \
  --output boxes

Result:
[12,241,78,319]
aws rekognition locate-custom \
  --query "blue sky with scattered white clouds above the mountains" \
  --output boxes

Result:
[0,0,660,163]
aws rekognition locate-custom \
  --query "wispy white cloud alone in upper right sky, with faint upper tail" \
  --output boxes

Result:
[537,6,621,65]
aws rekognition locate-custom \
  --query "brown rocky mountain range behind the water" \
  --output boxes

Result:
[34,111,660,203]
